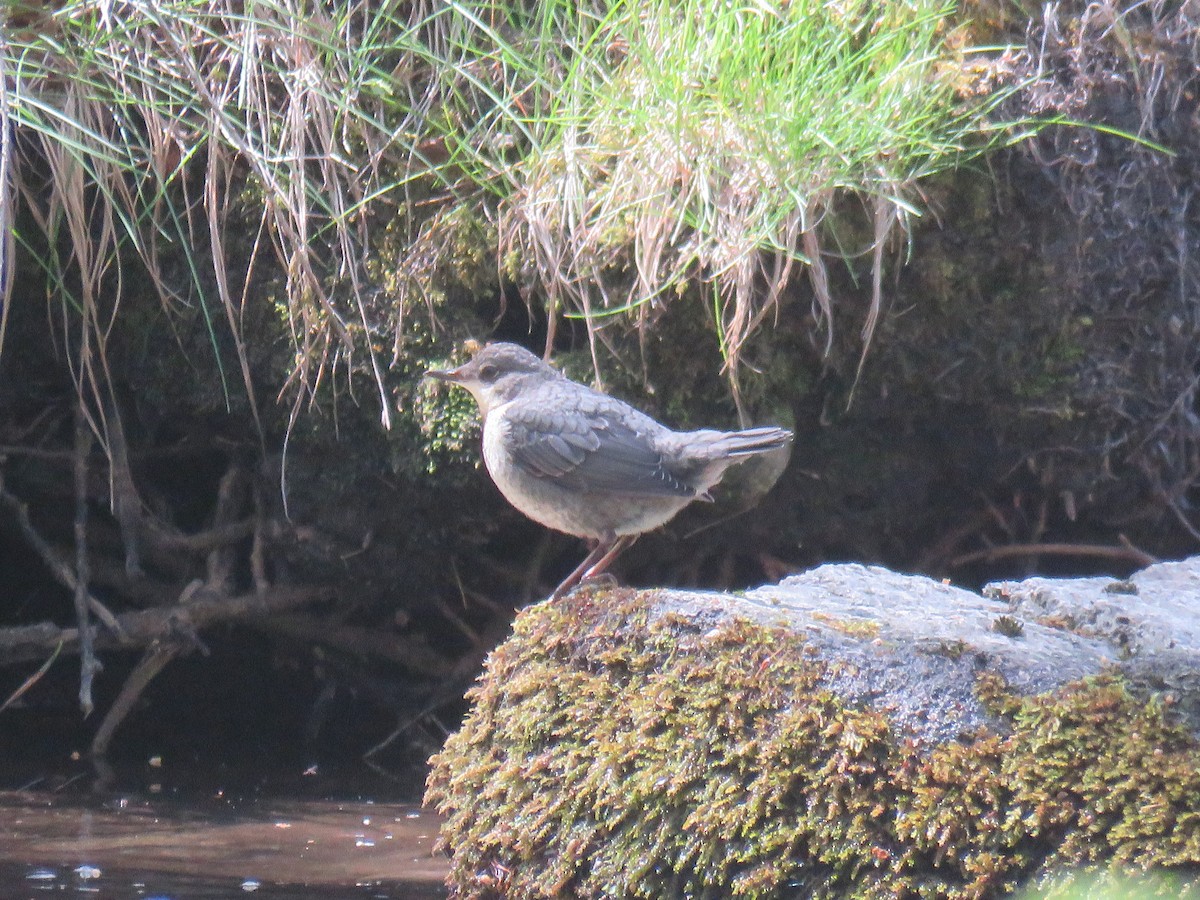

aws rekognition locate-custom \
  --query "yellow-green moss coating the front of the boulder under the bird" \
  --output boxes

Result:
[426,592,1200,898]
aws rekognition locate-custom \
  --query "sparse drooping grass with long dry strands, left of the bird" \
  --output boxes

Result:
[0,0,436,422]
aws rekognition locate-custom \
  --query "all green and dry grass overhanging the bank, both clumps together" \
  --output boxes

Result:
[0,0,1012,425]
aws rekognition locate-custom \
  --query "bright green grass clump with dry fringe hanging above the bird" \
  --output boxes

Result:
[508,0,1003,408]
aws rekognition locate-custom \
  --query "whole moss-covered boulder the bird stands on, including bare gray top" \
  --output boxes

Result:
[426,560,1200,898]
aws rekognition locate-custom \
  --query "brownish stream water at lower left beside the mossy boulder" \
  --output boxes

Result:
[0,791,446,900]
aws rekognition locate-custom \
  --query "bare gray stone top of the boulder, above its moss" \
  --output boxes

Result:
[655,557,1200,743]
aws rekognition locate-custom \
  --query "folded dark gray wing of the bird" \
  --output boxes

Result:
[506,404,696,497]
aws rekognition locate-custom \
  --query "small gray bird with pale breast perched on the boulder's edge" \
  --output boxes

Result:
[427,343,792,598]
